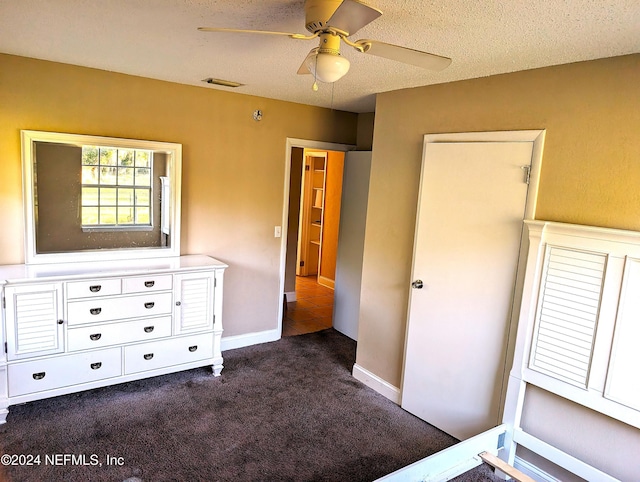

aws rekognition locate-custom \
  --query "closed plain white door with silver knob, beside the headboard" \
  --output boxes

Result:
[402,142,533,440]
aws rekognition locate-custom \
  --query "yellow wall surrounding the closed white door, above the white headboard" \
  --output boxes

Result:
[357,55,640,480]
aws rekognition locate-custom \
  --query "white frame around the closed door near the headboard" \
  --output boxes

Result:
[399,129,546,422]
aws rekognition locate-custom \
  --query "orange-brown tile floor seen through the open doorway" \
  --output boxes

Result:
[282,276,333,336]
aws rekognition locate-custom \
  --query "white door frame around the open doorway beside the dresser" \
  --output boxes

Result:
[277,137,356,339]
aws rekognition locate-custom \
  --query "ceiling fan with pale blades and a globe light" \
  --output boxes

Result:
[198,0,451,85]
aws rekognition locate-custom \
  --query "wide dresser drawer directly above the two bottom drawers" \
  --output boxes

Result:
[67,316,171,351]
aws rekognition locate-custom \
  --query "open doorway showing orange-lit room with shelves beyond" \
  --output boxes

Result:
[280,139,355,336]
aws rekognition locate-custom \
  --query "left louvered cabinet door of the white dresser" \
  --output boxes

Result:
[5,283,64,360]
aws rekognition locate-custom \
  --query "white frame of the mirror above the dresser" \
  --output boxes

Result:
[21,130,182,264]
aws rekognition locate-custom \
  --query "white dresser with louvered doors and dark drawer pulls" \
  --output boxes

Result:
[0,255,227,423]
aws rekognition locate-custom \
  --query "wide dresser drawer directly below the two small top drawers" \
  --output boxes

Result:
[67,293,173,326]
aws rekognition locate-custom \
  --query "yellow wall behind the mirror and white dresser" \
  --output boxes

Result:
[0,55,358,336]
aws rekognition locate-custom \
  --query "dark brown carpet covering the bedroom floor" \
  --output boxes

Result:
[0,329,497,482]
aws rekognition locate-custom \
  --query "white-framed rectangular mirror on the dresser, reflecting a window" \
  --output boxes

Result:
[22,131,182,264]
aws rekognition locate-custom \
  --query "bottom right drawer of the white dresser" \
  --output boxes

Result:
[124,333,213,375]
